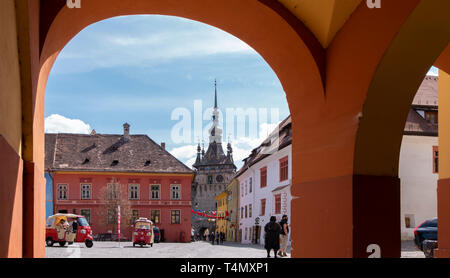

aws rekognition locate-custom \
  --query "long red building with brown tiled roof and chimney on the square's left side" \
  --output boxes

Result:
[45,124,194,242]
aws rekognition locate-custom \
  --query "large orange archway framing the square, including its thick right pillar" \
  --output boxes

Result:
[0,0,448,257]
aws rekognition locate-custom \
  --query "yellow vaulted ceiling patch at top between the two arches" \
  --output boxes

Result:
[278,0,362,48]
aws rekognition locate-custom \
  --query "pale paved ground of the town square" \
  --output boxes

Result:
[46,241,425,258]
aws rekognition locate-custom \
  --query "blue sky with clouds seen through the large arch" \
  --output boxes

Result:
[45,15,289,169]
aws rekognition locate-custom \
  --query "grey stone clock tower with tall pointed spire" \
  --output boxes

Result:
[192,85,236,234]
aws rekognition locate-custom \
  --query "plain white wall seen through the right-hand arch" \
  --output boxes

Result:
[399,135,438,240]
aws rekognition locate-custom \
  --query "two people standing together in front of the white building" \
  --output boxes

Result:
[264,215,289,258]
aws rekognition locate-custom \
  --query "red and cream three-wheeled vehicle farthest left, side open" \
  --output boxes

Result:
[45,213,94,248]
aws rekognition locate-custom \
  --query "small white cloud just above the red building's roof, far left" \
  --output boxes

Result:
[44,114,91,134]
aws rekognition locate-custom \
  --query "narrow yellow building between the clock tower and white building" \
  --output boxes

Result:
[226,179,240,242]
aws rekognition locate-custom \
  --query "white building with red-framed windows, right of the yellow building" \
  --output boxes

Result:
[235,117,292,245]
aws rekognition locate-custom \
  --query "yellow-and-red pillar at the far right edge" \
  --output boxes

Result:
[435,70,450,258]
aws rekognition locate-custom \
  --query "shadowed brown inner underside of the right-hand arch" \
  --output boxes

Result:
[353,1,450,255]
